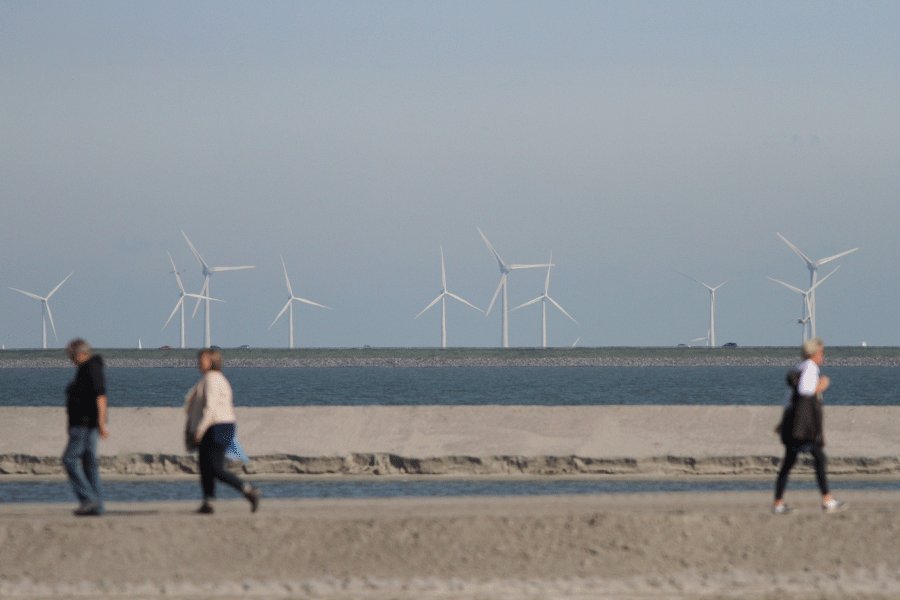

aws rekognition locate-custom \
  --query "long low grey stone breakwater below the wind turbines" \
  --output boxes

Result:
[0,355,900,369]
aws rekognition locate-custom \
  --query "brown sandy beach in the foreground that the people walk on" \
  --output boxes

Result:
[0,492,900,600]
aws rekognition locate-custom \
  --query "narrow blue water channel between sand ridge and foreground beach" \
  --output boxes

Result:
[0,476,900,504]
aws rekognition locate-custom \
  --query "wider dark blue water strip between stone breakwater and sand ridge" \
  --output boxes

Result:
[0,365,900,407]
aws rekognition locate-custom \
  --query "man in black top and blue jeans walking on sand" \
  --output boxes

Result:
[63,338,109,516]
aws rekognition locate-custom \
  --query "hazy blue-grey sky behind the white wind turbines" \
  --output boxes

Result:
[0,0,900,348]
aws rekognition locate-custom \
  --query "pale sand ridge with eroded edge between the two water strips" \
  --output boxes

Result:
[0,405,900,477]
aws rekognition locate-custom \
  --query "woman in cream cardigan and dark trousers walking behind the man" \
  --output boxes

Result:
[184,348,260,514]
